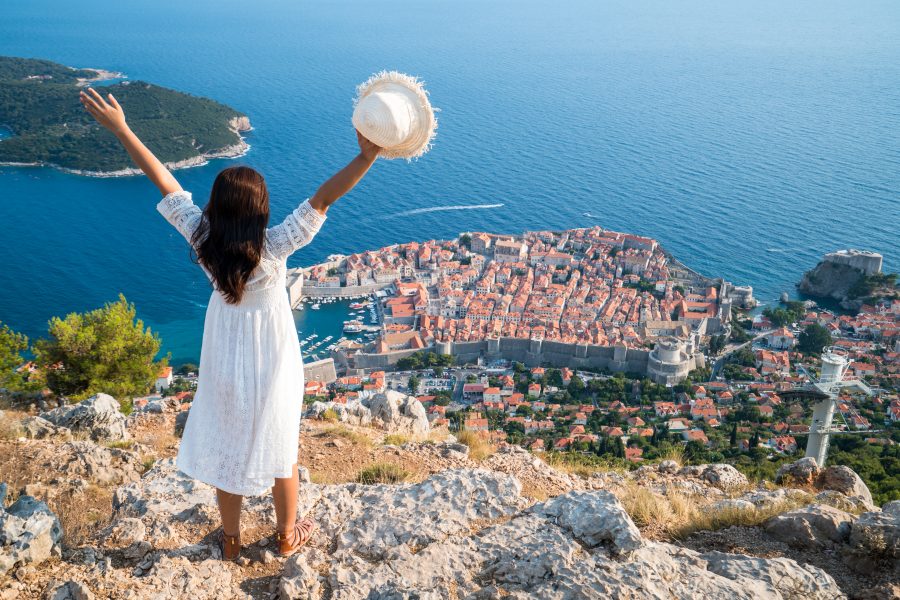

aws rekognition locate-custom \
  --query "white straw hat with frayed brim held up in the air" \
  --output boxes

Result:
[353,71,437,160]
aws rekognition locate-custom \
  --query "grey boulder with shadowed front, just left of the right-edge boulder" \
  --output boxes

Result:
[765,504,853,548]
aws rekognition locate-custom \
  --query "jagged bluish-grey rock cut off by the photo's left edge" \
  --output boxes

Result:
[0,496,62,575]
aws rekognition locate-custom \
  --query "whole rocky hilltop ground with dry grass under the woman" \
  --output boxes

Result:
[0,396,900,600]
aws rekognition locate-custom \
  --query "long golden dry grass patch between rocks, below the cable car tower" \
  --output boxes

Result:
[617,483,811,539]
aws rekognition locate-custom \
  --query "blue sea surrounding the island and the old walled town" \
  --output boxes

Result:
[0,0,900,362]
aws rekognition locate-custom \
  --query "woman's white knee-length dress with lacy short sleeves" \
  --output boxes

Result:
[157,192,325,496]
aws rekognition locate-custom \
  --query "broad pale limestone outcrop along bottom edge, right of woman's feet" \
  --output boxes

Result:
[288,469,843,600]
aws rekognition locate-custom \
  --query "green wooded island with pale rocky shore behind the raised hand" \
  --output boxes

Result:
[0,56,250,177]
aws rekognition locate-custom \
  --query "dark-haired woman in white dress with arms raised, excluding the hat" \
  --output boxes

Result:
[81,89,380,560]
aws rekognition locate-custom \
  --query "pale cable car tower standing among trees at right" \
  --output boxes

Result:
[781,346,872,466]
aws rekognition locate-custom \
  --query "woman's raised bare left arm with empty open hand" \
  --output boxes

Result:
[81,88,181,196]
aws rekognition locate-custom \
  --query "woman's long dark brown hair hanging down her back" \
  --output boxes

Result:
[191,167,269,304]
